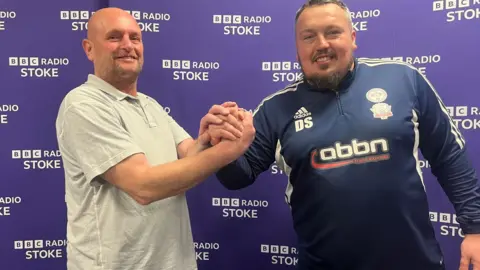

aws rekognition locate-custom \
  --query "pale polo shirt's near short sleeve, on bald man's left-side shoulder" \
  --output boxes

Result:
[58,101,143,182]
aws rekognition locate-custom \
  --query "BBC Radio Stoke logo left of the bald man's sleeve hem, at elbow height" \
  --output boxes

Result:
[12,149,62,170]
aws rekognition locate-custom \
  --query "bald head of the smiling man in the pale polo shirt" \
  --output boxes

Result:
[82,7,143,95]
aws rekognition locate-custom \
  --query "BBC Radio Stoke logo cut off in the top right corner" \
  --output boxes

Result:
[433,0,480,23]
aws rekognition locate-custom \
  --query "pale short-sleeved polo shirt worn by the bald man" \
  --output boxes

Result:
[56,75,197,270]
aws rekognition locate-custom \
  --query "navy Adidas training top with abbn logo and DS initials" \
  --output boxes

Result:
[217,58,480,270]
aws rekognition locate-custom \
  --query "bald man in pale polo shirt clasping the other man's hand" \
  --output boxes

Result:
[56,8,254,270]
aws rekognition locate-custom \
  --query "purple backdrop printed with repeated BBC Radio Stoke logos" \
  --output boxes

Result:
[0,0,480,270]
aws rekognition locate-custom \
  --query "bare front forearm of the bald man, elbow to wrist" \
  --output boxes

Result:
[137,146,233,204]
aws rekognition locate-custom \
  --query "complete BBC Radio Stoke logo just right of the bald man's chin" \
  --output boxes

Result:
[162,59,220,82]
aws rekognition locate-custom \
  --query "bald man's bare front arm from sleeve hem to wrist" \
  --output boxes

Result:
[103,141,242,205]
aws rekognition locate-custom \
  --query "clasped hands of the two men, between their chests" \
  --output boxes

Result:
[198,102,255,157]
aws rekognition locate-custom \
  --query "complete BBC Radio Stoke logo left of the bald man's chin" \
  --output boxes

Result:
[8,57,70,78]
